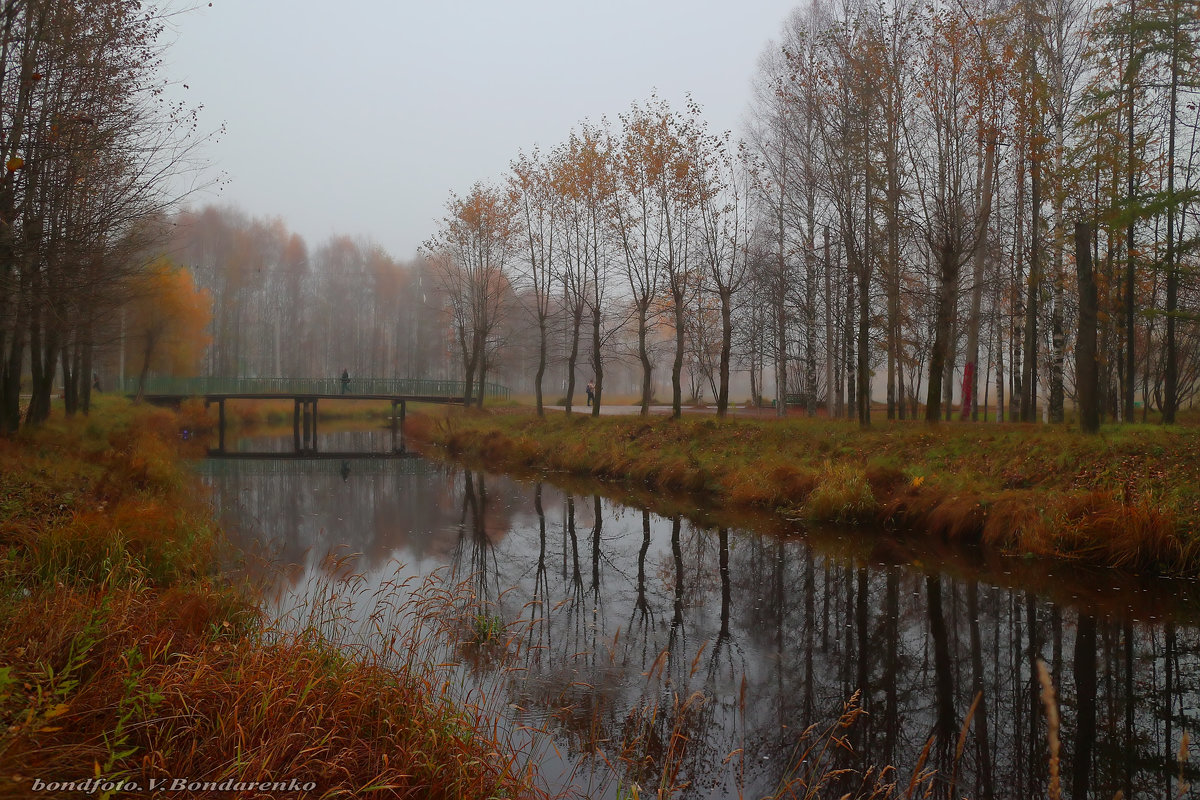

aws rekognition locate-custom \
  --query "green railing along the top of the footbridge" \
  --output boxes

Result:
[118,377,509,399]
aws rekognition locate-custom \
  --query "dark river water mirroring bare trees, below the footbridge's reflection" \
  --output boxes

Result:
[209,462,1200,798]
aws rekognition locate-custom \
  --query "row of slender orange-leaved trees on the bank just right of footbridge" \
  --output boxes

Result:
[425,98,751,414]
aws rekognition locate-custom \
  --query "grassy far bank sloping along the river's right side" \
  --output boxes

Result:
[409,410,1200,575]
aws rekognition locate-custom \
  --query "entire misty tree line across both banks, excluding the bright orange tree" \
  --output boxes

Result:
[0,0,1200,431]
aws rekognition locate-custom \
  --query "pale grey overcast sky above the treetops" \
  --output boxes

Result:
[159,0,796,258]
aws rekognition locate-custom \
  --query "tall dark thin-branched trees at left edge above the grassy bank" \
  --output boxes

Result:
[0,0,208,434]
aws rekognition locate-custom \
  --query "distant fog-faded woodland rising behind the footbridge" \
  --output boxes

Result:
[168,206,452,378]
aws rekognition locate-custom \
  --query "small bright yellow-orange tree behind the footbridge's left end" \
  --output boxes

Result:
[125,258,212,393]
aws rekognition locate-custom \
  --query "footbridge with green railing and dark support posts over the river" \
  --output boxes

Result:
[119,378,509,452]
